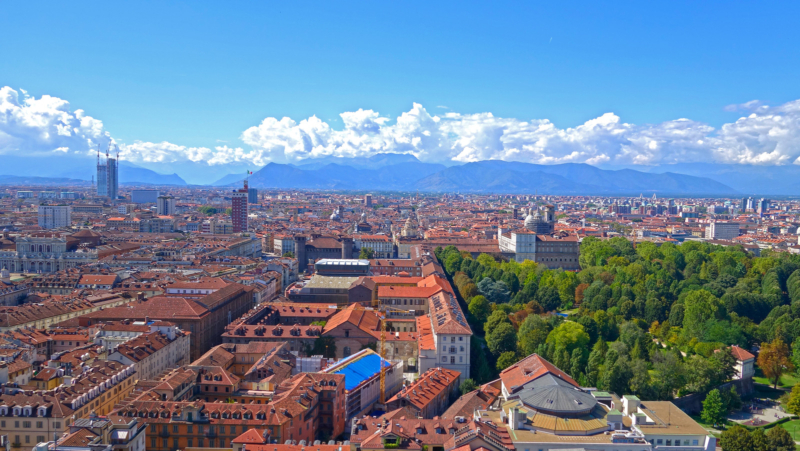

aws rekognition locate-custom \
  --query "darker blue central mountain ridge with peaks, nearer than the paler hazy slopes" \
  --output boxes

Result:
[239,157,738,195]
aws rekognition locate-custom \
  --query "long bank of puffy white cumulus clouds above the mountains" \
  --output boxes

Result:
[0,87,800,166]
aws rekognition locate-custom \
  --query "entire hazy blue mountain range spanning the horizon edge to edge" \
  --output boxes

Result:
[9,154,800,196]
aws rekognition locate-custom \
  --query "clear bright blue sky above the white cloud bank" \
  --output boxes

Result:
[0,1,800,181]
